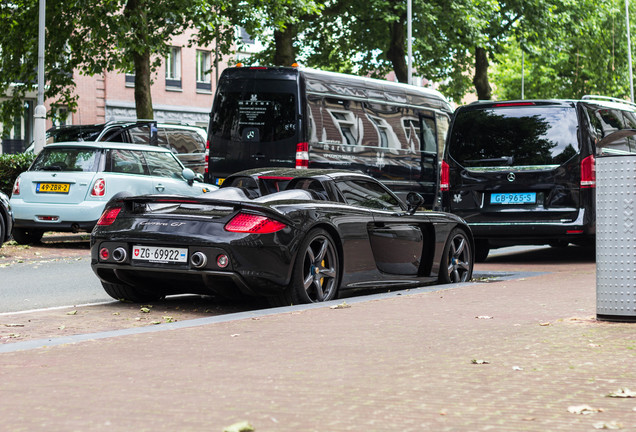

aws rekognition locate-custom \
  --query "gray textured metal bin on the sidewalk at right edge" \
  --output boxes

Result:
[596,154,636,321]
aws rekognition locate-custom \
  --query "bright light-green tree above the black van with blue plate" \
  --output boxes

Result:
[493,0,629,99]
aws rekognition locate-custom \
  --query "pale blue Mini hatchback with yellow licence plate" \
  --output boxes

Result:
[10,142,217,244]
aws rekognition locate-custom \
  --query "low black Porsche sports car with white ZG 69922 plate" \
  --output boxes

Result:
[91,169,474,305]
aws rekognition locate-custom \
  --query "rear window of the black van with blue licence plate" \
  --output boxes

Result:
[449,105,578,170]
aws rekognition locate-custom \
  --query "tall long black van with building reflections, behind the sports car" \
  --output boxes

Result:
[207,67,452,206]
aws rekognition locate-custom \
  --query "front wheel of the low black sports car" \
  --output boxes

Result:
[439,228,473,283]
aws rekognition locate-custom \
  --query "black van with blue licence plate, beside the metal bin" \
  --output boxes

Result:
[440,96,636,261]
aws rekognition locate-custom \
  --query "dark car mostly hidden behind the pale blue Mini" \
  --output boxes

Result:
[27,120,208,175]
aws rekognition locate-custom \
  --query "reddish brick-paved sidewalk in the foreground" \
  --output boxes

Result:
[0,255,636,432]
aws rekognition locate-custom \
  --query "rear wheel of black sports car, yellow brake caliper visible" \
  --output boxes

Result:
[279,228,340,305]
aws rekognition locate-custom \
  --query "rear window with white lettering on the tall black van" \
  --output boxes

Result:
[210,89,297,142]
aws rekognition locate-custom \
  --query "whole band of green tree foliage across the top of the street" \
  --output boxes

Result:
[0,0,633,123]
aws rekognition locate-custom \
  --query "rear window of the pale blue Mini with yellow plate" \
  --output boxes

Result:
[29,147,99,172]
